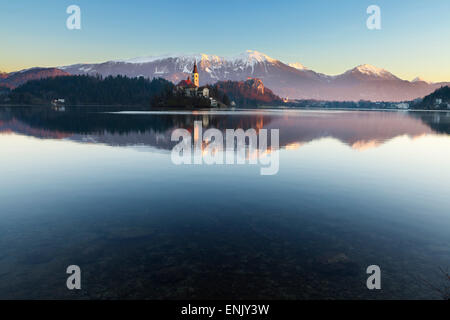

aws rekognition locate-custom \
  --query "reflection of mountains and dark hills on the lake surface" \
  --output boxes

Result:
[0,107,450,151]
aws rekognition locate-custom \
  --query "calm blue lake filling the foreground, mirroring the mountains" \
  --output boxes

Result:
[0,107,450,299]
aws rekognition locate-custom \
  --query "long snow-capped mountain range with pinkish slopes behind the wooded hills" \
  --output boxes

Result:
[0,50,450,101]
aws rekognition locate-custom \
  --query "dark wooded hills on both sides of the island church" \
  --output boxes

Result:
[0,75,282,108]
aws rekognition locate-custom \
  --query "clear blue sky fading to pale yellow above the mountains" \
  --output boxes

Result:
[0,0,450,81]
